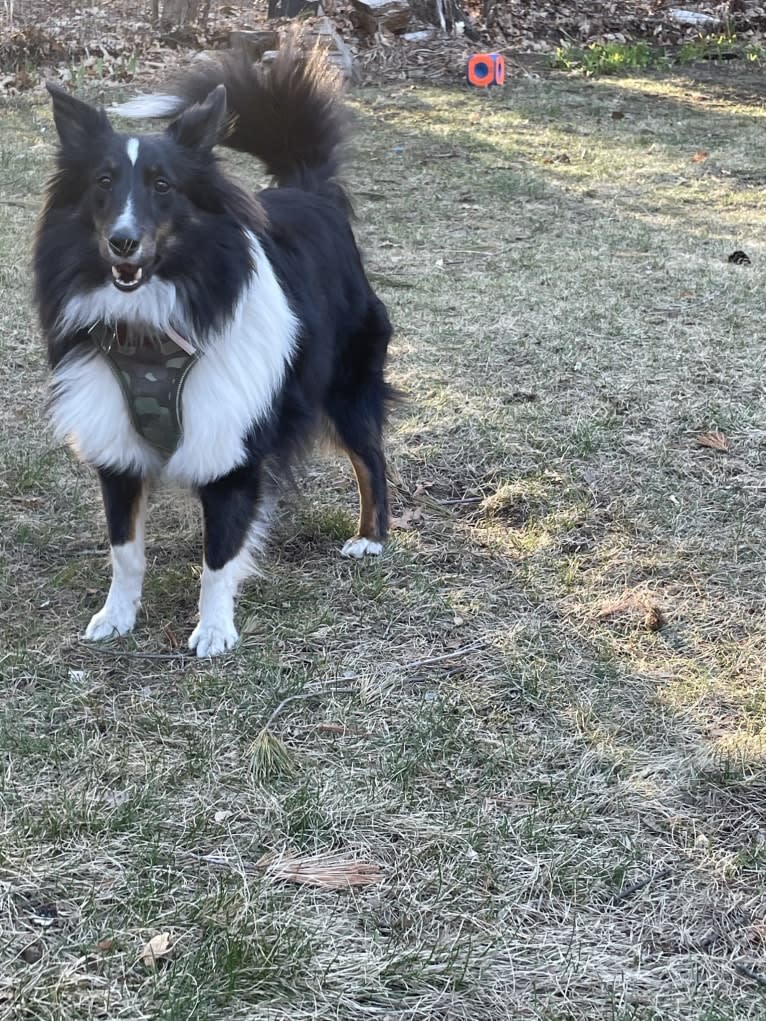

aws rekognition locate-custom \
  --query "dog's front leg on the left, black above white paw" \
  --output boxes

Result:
[85,470,146,641]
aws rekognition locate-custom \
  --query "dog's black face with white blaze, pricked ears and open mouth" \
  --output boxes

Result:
[48,85,226,301]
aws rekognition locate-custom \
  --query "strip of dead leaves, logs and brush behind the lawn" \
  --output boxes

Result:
[0,0,766,88]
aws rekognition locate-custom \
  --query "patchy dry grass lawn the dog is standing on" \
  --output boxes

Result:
[0,65,766,1021]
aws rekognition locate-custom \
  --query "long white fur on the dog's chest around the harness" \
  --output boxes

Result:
[51,237,298,485]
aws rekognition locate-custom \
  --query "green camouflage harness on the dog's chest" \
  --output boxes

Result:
[91,323,197,457]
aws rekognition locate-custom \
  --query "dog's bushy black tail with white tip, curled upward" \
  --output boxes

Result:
[111,44,348,191]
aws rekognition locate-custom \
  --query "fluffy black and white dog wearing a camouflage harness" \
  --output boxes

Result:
[33,46,393,657]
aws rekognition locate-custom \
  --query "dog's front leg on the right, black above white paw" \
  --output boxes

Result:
[189,466,270,655]
